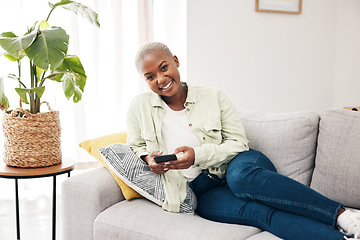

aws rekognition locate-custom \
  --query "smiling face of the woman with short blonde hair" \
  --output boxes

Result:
[138,50,182,97]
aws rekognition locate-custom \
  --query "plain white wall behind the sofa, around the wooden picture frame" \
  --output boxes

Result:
[187,0,360,112]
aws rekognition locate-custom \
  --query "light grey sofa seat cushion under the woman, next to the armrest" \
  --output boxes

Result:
[94,199,279,240]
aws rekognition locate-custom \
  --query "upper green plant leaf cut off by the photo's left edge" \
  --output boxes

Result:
[0,30,37,55]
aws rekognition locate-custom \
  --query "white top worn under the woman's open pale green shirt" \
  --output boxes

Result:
[161,101,201,182]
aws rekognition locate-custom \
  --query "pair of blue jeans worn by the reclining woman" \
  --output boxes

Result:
[190,150,344,240]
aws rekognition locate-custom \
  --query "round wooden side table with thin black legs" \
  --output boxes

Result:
[0,160,75,240]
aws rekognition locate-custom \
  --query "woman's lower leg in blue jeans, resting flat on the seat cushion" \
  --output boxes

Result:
[195,185,344,240]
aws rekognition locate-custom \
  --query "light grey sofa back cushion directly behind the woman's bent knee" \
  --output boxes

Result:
[240,112,319,186]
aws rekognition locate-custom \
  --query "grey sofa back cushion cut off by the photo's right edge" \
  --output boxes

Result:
[311,109,360,208]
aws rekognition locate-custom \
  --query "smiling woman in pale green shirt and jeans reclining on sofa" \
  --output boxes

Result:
[128,42,360,240]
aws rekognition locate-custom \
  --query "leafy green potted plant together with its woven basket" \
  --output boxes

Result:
[0,0,100,167]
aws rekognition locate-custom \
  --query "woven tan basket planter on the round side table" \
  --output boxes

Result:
[3,102,62,168]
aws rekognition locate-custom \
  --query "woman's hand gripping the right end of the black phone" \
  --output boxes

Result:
[165,146,195,169]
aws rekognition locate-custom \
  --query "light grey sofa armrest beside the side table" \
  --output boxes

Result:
[61,167,125,240]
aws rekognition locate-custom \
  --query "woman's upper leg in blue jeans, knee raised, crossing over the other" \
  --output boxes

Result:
[226,150,341,227]
